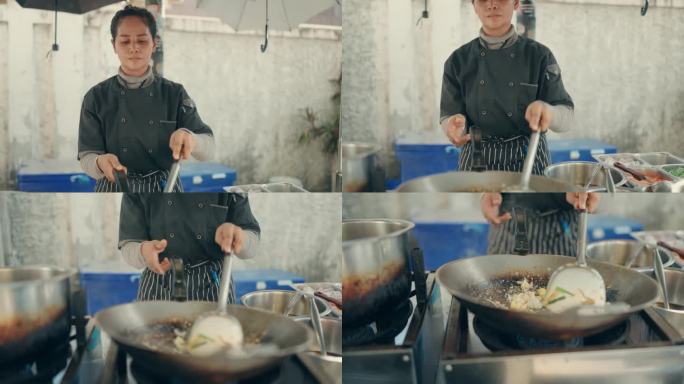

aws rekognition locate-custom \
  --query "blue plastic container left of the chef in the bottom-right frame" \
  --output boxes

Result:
[412,211,489,271]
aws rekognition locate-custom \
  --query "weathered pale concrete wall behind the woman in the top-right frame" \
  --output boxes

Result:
[341,0,684,176]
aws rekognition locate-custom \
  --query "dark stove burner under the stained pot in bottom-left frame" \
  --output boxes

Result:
[0,343,72,384]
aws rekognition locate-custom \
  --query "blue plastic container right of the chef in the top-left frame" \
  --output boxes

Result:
[179,162,237,192]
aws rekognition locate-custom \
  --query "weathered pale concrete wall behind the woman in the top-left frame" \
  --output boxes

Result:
[0,0,341,190]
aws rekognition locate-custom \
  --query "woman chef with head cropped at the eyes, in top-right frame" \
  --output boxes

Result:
[440,0,573,174]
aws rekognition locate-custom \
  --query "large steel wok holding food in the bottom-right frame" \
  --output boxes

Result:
[437,255,658,340]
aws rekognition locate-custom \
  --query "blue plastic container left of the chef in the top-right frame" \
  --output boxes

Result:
[394,133,461,183]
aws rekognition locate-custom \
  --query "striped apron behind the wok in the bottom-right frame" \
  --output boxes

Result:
[487,209,578,256]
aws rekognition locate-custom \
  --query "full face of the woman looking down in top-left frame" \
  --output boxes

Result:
[114,16,157,76]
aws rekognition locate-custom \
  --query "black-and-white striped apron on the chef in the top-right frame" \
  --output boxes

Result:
[458,134,549,175]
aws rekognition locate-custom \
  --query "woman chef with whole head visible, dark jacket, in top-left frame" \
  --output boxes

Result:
[78,5,214,192]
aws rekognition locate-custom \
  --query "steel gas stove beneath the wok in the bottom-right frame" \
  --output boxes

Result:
[437,298,684,384]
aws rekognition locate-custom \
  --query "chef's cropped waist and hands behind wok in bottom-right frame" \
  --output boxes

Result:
[480,192,600,256]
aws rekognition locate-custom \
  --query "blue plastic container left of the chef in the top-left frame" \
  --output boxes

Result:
[17,160,95,192]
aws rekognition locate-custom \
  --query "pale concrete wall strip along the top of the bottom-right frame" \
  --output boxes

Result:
[342,193,684,230]
